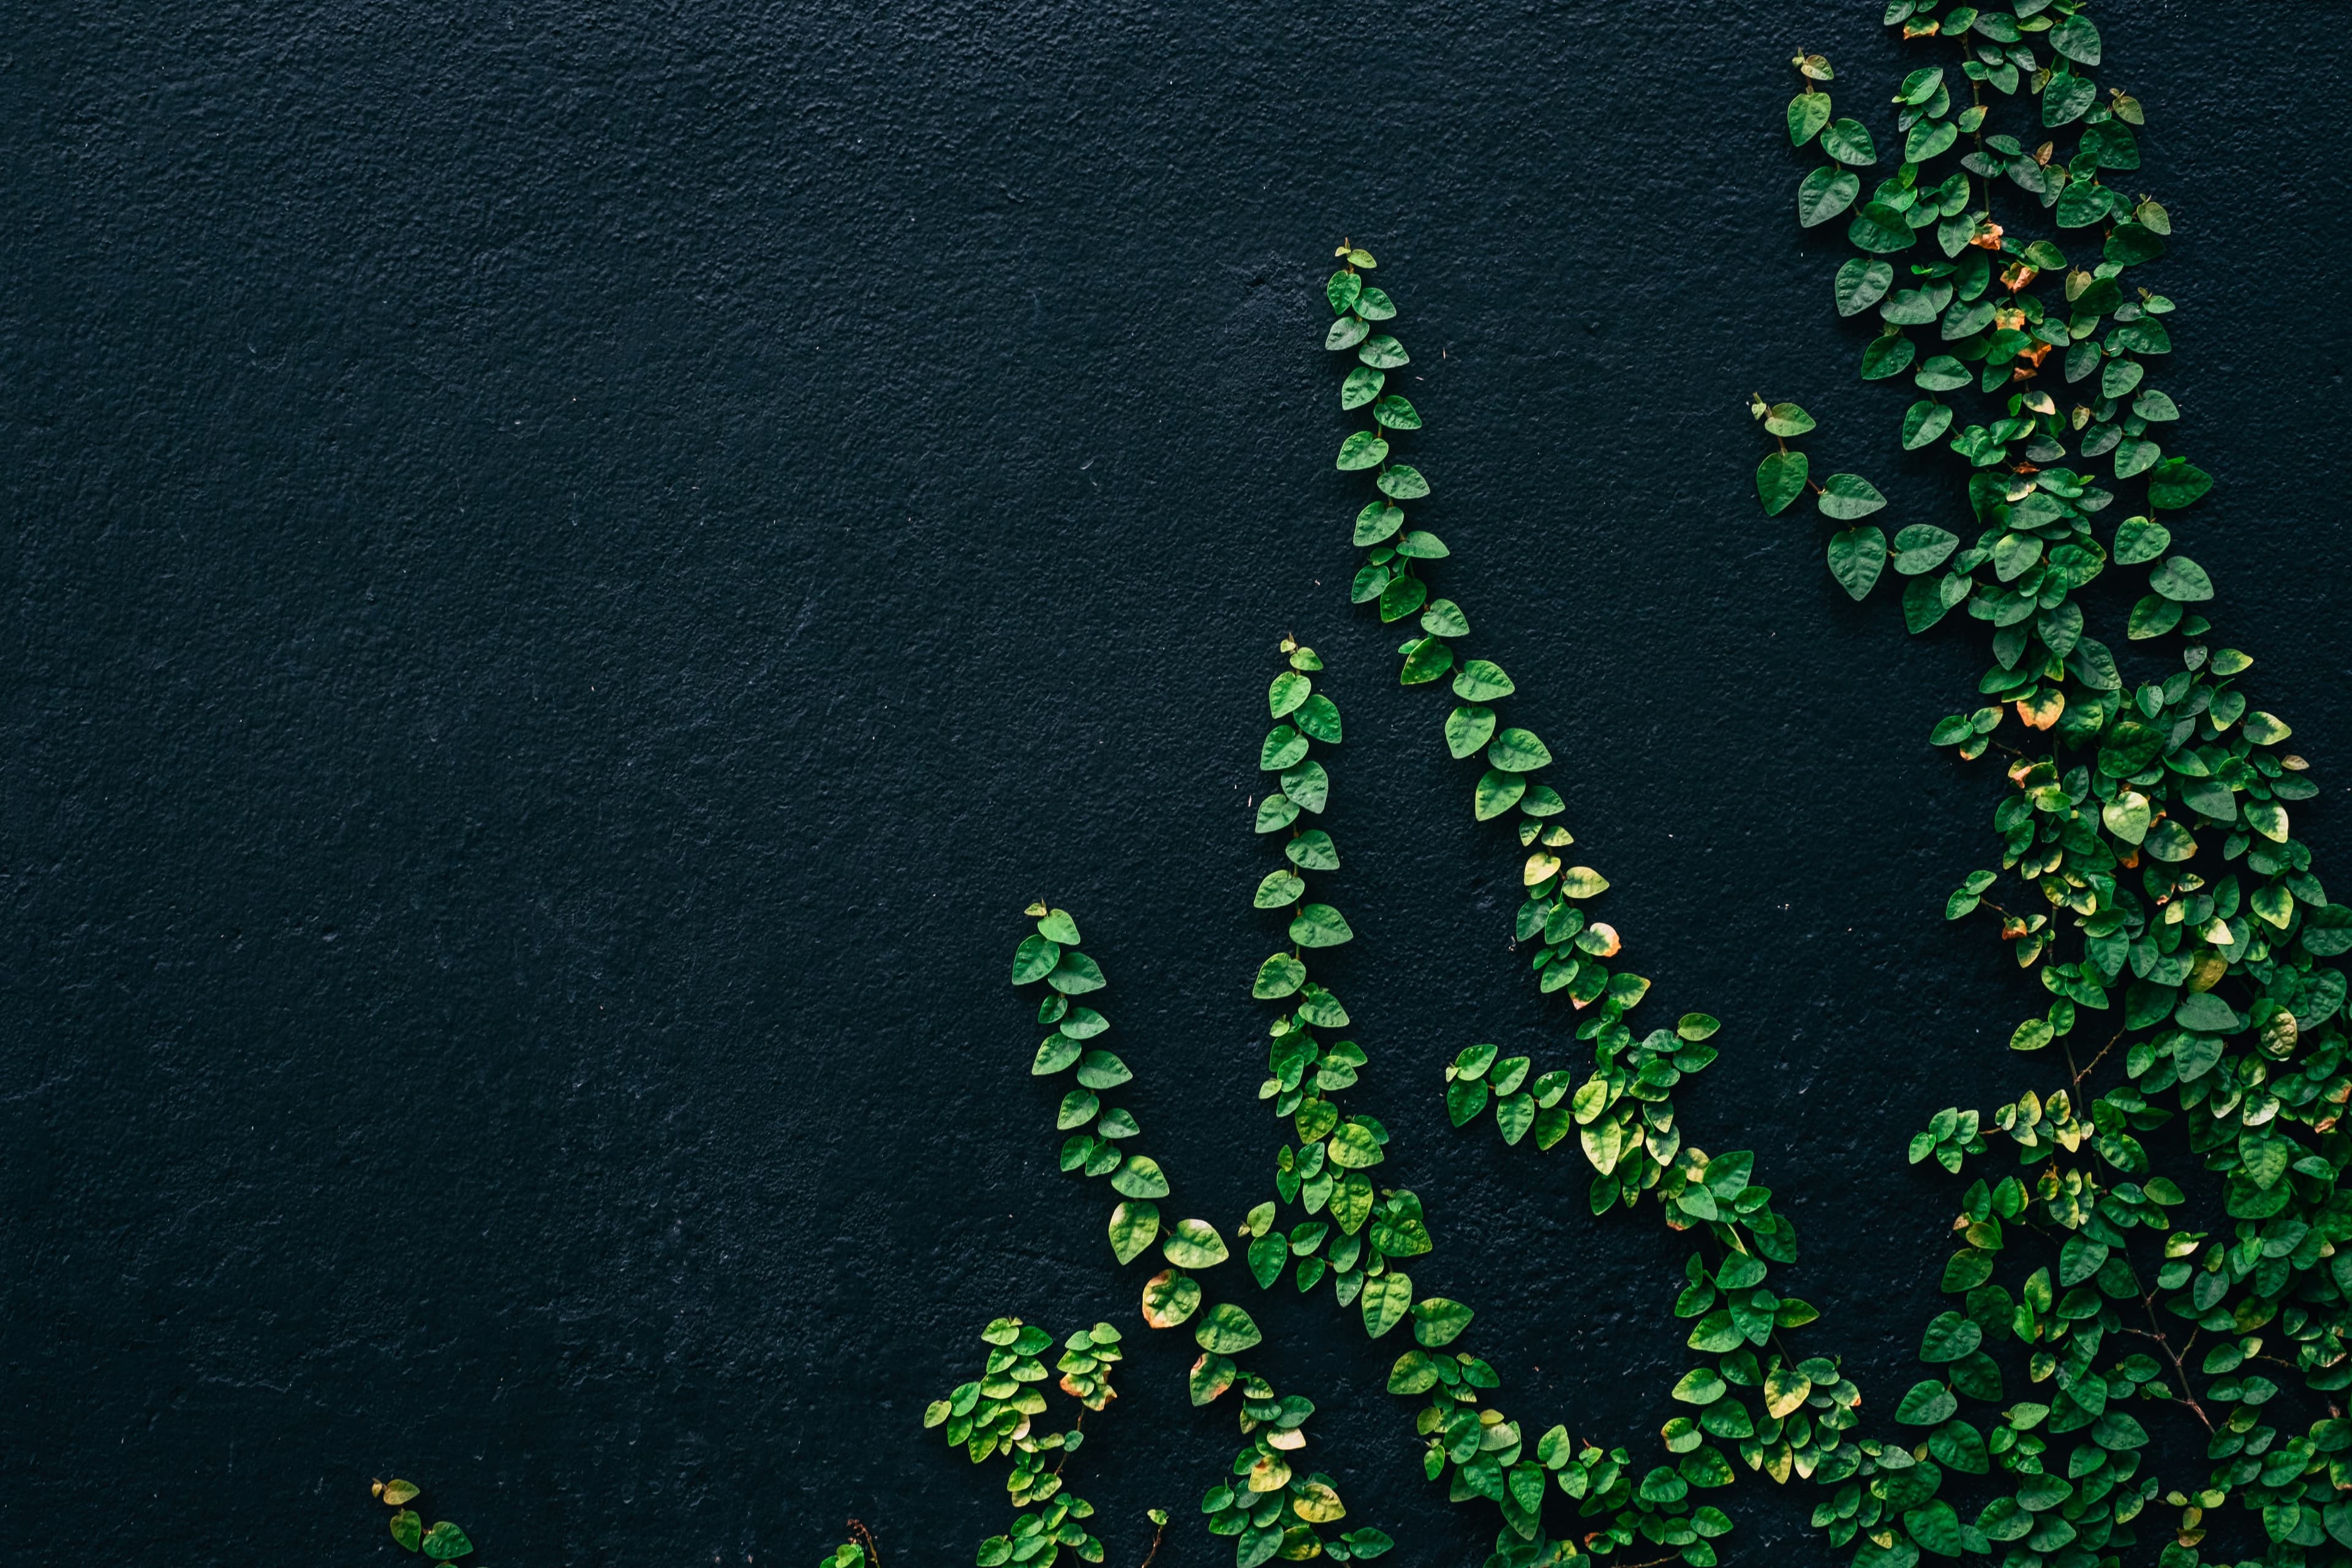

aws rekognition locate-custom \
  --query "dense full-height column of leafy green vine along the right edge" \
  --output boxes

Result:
[1752,0,2352,1568]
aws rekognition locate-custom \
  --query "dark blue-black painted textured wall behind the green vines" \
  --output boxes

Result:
[0,0,2352,1568]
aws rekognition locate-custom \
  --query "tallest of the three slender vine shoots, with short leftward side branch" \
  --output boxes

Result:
[1324,244,1879,1563]
